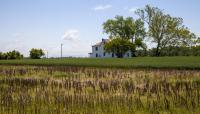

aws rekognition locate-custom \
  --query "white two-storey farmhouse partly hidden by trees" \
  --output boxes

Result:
[89,39,131,58]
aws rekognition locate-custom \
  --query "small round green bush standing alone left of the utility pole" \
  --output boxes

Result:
[30,48,45,59]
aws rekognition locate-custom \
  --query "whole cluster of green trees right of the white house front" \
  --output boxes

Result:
[103,5,200,58]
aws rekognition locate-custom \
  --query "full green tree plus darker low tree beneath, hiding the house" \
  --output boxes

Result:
[103,16,146,58]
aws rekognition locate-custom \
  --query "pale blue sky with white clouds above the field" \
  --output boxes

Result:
[0,0,200,57]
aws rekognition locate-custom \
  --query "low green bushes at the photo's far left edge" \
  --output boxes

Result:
[0,50,23,60]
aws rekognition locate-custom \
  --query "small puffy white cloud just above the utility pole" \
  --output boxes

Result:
[62,29,79,40]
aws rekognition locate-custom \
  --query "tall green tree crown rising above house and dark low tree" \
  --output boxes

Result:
[103,16,146,55]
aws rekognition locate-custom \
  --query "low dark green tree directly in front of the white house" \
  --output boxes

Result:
[104,38,135,58]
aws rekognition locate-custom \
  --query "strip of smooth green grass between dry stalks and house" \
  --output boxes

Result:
[0,56,200,69]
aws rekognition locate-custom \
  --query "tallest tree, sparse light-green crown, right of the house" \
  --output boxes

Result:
[136,5,196,56]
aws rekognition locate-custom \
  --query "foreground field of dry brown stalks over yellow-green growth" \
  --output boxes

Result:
[0,65,200,114]
